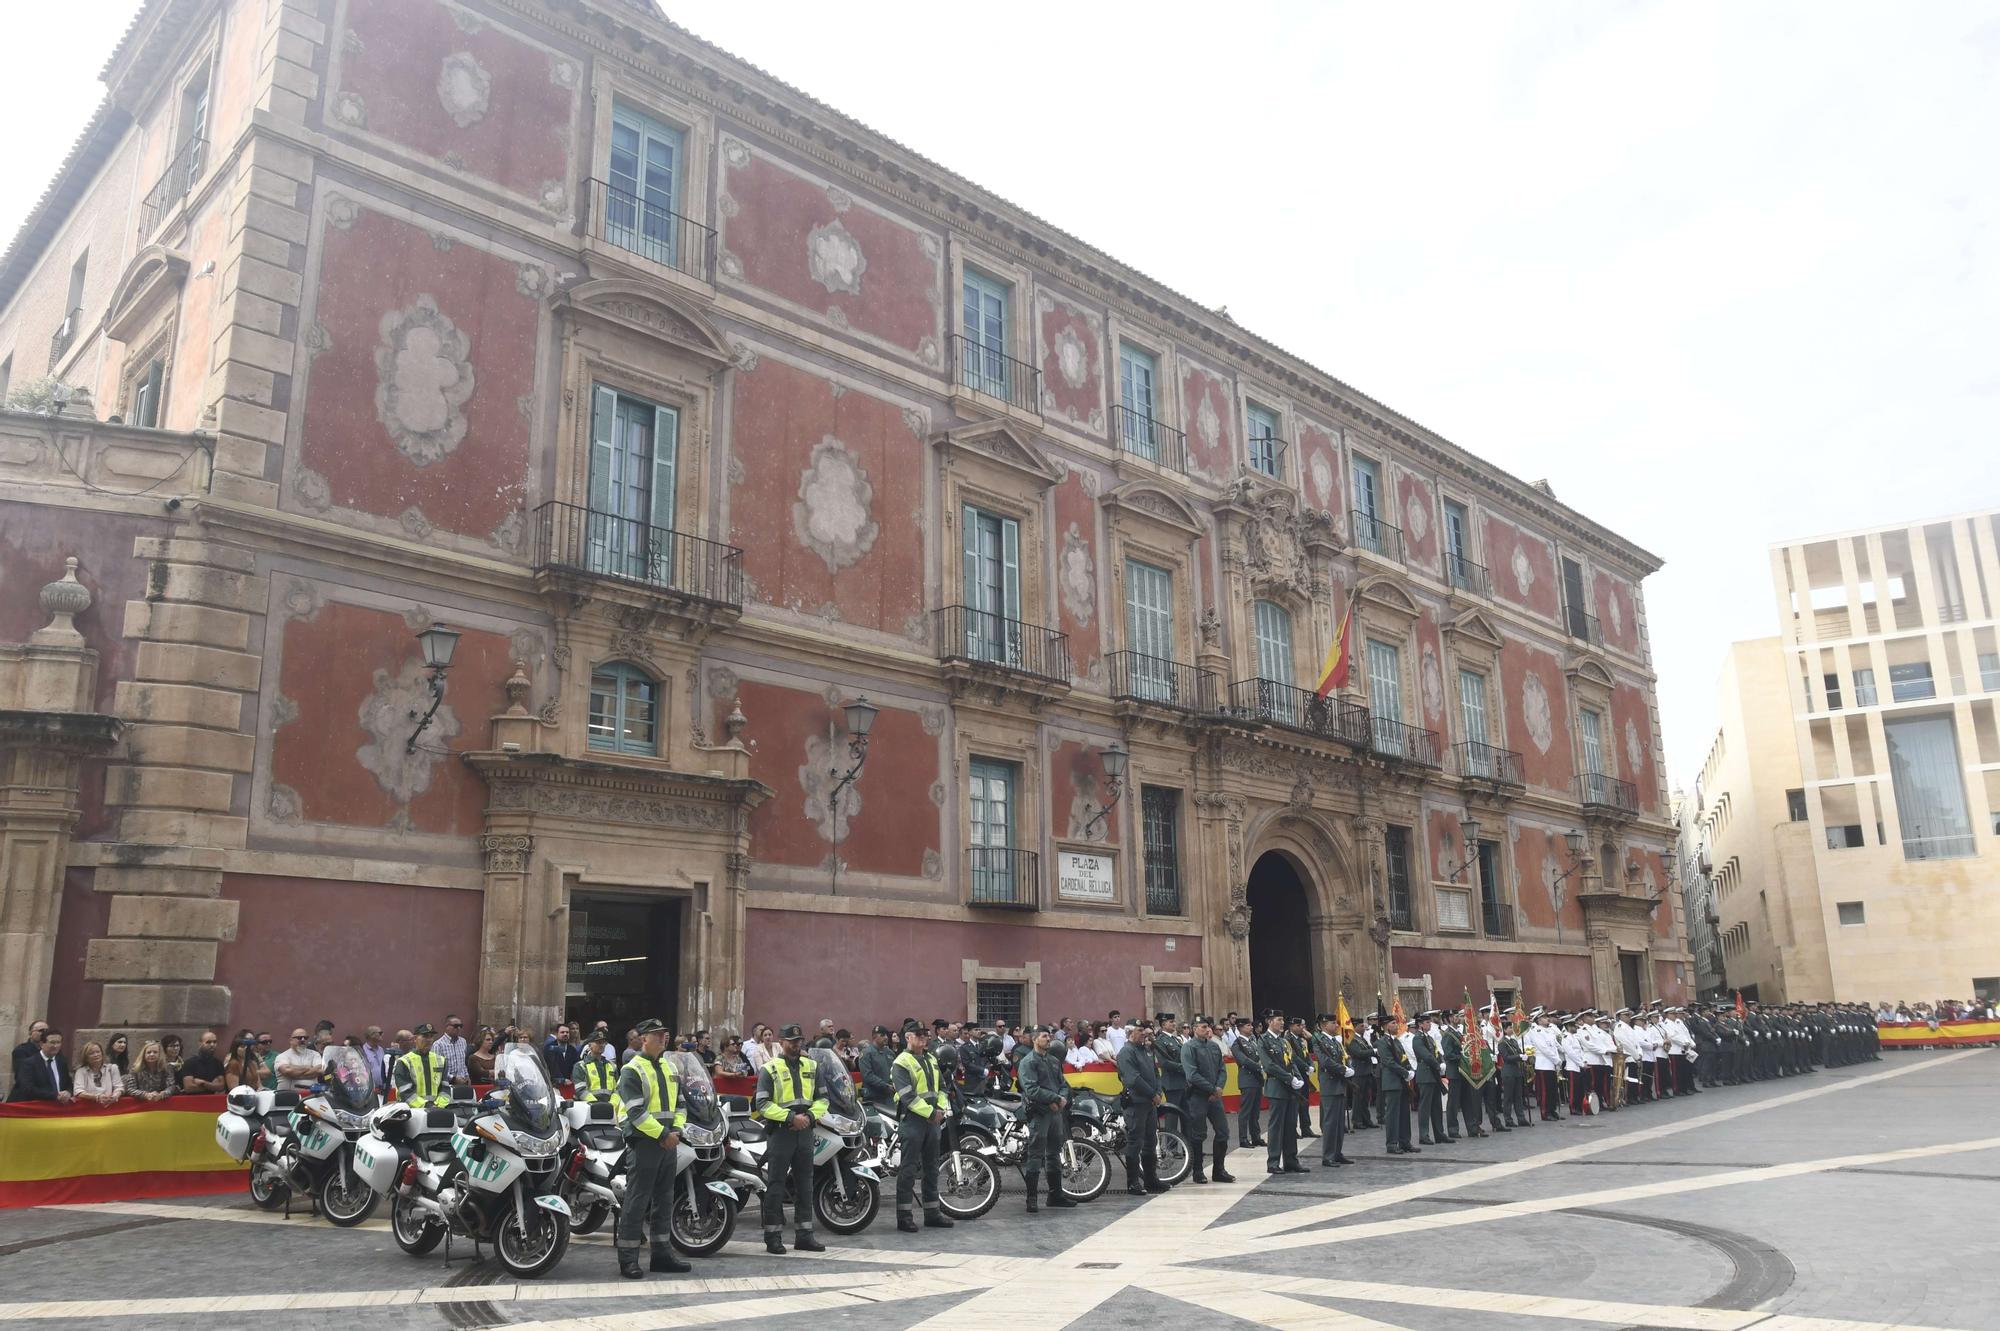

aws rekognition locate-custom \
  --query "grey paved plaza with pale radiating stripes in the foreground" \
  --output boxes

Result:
[0,1049,2000,1331]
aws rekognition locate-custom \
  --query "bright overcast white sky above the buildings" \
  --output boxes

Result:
[0,0,2000,783]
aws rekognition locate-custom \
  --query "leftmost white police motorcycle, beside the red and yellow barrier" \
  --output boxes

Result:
[216,1045,376,1229]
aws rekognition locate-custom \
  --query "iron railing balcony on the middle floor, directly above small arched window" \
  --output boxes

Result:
[534,500,744,610]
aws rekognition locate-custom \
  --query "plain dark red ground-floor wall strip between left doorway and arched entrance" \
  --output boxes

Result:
[744,907,1202,1031]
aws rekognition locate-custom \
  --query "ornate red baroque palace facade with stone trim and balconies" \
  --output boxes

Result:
[0,0,1690,1055]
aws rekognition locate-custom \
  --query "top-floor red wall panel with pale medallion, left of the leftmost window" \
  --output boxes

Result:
[334,0,582,198]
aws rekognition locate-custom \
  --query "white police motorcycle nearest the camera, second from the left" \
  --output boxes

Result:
[356,1043,572,1279]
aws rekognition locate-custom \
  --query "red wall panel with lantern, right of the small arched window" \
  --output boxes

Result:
[738,679,940,875]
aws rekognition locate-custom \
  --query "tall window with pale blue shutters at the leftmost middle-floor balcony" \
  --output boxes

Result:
[588,384,680,584]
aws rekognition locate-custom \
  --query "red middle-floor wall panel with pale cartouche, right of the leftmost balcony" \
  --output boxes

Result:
[730,358,924,646]
